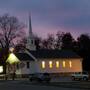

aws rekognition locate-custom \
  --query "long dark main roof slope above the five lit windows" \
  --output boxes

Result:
[30,50,81,59]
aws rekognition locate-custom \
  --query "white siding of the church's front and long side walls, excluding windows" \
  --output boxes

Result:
[16,59,82,74]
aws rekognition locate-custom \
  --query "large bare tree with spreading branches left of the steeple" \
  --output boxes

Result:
[0,14,24,74]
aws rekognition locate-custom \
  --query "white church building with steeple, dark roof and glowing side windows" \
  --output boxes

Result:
[7,17,83,75]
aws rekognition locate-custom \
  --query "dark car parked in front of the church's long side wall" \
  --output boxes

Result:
[29,73,51,83]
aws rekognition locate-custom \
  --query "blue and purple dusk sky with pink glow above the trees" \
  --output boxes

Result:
[0,0,90,37]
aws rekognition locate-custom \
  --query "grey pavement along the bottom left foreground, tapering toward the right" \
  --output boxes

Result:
[0,80,86,90]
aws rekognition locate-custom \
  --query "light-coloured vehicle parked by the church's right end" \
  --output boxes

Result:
[71,72,89,80]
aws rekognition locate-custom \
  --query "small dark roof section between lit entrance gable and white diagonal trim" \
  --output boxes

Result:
[15,53,34,61]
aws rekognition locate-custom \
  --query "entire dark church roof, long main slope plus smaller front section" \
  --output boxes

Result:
[15,50,81,61]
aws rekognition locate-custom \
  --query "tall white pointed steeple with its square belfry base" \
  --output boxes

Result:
[26,14,36,50]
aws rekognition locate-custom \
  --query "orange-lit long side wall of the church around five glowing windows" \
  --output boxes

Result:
[34,59,82,73]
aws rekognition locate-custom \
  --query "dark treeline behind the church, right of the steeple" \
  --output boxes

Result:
[35,32,90,71]
